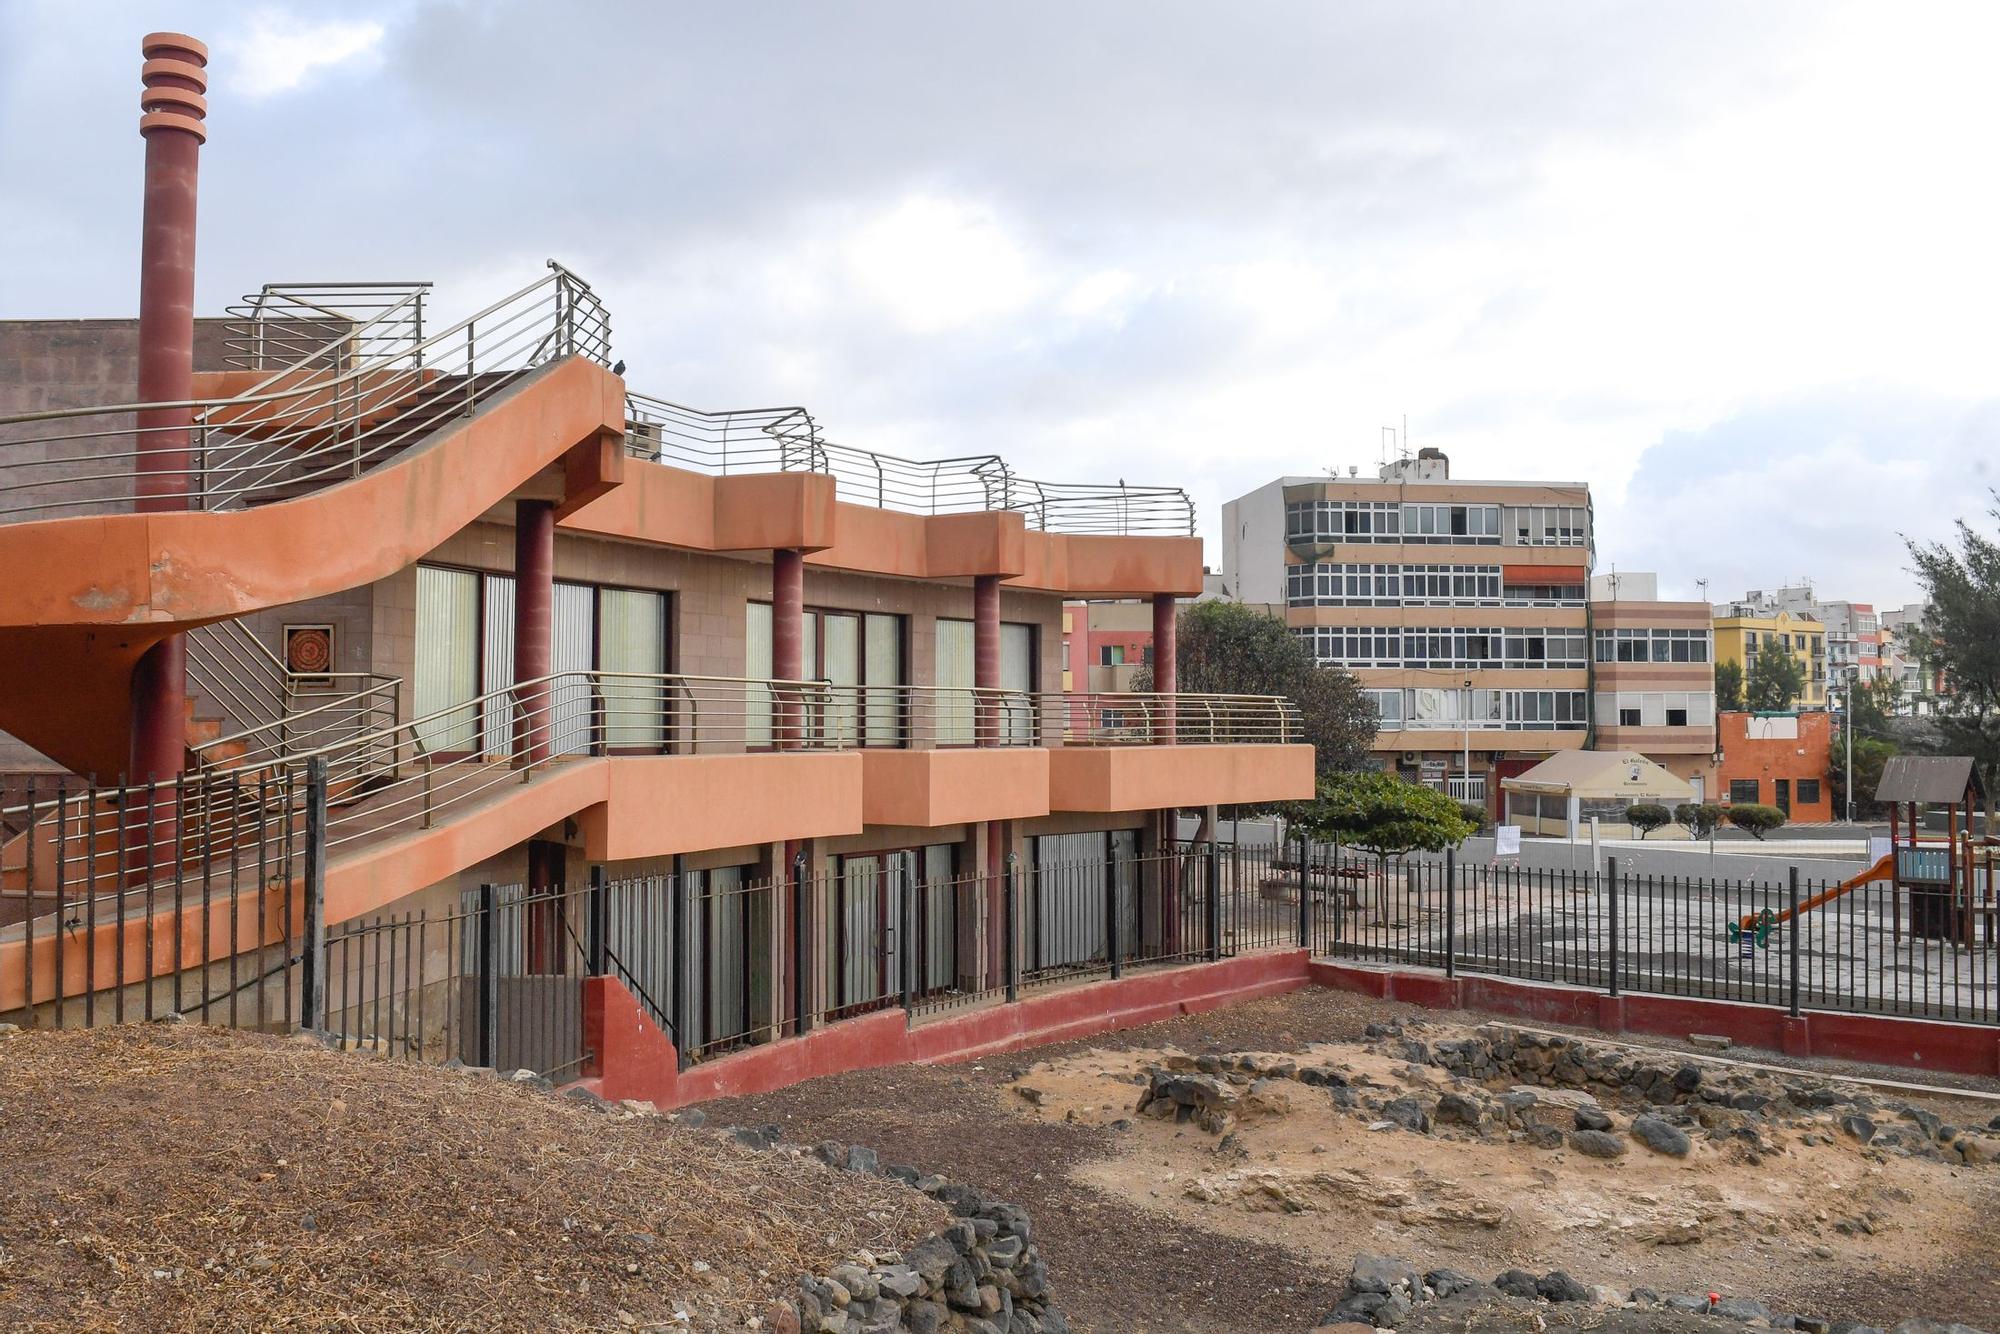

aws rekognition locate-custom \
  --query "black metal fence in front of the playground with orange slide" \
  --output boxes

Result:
[1280,844,2000,1024]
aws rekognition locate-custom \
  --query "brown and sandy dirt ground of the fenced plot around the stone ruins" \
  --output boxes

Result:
[710,990,2000,1330]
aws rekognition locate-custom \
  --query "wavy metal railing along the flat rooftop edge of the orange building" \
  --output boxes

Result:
[626,394,1194,536]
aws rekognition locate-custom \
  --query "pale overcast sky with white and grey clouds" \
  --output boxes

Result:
[0,0,2000,606]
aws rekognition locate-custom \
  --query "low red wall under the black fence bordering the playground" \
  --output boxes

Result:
[1308,962,2000,1074]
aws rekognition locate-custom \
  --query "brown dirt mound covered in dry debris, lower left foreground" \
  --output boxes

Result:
[0,1024,946,1330]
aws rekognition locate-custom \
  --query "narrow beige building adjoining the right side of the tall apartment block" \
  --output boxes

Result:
[1590,572,1716,800]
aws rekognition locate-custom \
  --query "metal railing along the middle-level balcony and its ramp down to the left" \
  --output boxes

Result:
[0,672,1302,908]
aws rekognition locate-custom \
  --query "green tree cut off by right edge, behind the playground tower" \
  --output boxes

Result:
[1908,492,2000,830]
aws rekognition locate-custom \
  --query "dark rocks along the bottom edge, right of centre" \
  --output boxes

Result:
[1320,1254,1982,1334]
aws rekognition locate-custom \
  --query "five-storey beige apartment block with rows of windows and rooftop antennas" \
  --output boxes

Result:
[1222,450,1592,802]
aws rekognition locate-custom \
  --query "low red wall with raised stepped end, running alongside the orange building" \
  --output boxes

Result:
[578,950,1308,1108]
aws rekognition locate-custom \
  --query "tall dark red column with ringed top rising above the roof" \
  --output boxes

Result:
[128,32,208,782]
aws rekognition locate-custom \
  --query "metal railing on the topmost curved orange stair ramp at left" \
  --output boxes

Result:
[0,260,610,522]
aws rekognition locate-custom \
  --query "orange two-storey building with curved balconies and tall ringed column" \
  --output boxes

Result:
[0,34,1312,1078]
